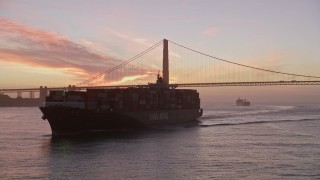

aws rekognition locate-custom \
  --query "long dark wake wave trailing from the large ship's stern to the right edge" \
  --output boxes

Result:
[199,118,320,127]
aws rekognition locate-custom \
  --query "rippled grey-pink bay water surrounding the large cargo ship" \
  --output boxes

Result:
[0,105,320,179]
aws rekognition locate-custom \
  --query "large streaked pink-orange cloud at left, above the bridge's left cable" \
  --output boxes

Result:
[0,17,122,83]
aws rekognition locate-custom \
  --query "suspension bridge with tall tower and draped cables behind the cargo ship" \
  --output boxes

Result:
[0,39,320,98]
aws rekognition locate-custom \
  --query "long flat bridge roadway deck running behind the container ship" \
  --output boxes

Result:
[0,80,320,93]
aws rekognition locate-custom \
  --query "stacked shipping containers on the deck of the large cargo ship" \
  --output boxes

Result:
[48,87,200,111]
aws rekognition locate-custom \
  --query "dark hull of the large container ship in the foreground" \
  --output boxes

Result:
[40,107,202,136]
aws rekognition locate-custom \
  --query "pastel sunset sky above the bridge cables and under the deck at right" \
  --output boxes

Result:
[0,0,320,102]
